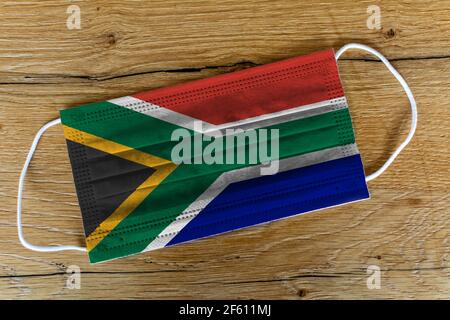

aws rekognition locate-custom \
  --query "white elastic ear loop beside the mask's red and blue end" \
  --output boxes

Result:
[336,43,417,181]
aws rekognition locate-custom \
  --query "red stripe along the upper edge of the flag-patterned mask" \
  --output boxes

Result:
[134,49,344,125]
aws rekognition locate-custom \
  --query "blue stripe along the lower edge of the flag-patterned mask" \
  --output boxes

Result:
[167,154,369,246]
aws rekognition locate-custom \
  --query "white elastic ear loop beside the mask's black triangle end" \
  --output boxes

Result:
[17,119,86,252]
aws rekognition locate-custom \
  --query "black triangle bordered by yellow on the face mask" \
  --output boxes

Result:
[66,140,155,236]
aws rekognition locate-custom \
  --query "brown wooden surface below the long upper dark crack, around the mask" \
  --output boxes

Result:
[0,60,450,298]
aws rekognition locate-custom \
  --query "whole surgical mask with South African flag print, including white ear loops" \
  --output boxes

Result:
[17,44,417,263]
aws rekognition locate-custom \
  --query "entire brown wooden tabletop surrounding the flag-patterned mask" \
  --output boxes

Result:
[0,0,450,299]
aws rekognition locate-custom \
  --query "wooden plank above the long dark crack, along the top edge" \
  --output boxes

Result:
[0,0,450,82]
